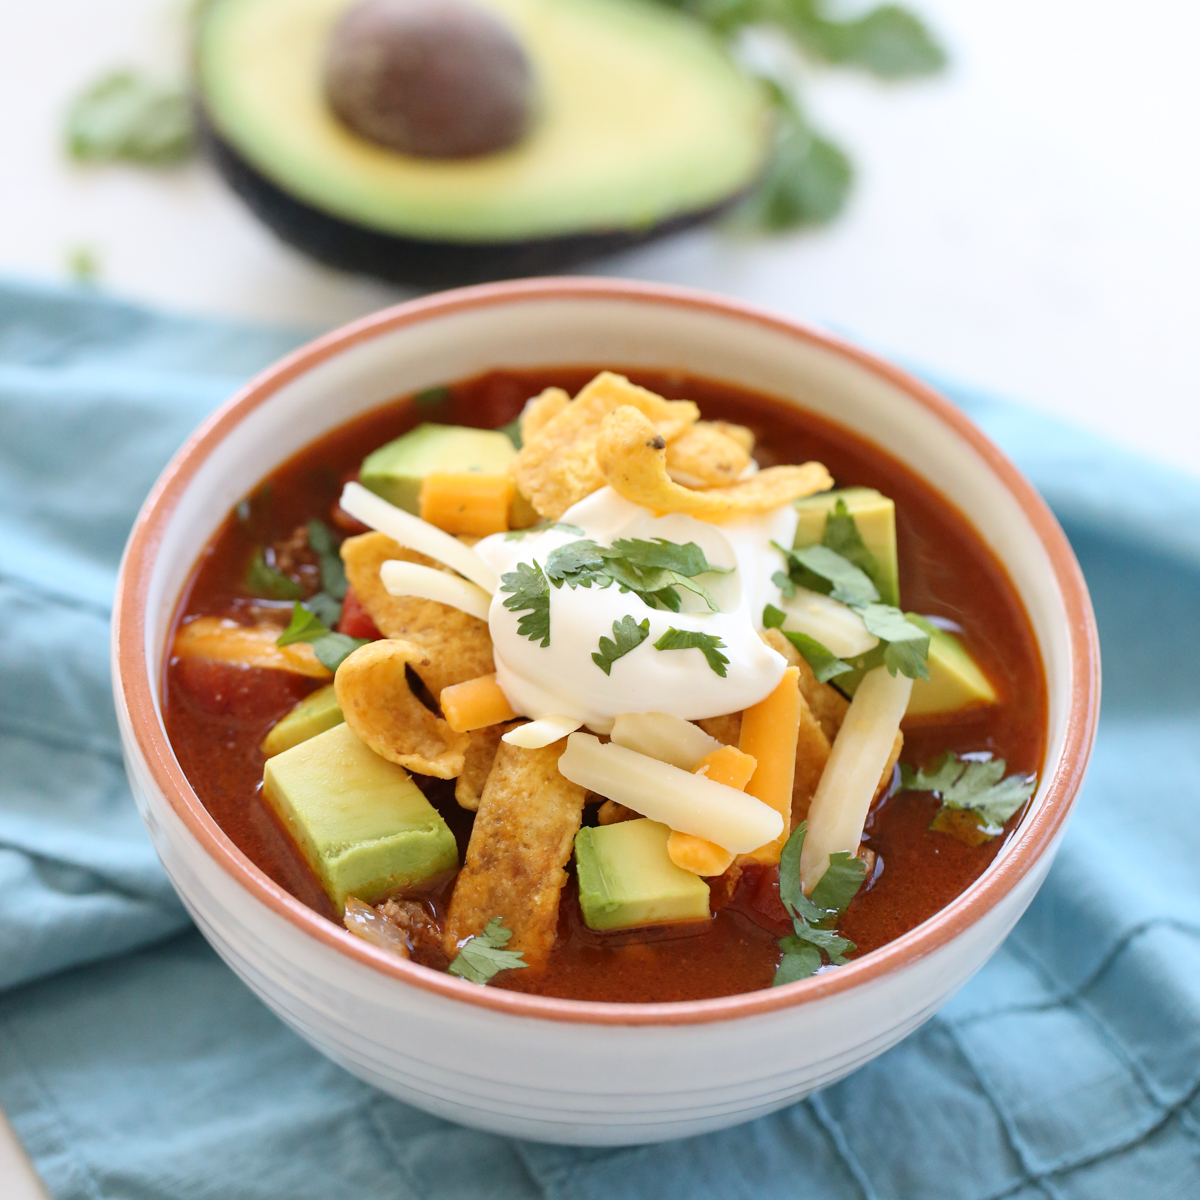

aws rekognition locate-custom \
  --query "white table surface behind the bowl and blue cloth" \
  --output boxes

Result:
[0,0,1200,1200]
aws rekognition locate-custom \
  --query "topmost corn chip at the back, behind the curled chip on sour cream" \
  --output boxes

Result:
[512,371,700,521]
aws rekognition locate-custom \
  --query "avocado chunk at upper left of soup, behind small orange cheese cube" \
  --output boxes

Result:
[359,425,517,512]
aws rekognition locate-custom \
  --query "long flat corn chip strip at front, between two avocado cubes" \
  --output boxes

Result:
[444,739,586,970]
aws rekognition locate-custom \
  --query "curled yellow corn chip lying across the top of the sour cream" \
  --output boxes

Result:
[595,404,833,522]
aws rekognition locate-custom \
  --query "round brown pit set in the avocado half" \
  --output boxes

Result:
[324,0,534,158]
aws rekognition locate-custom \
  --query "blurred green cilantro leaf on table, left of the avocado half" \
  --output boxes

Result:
[66,71,196,167]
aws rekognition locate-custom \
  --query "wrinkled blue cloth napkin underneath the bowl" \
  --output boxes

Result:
[0,287,1200,1200]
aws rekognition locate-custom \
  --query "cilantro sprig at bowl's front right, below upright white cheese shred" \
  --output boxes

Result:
[772,821,866,988]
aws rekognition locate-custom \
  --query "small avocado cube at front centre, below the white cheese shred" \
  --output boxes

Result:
[575,818,708,929]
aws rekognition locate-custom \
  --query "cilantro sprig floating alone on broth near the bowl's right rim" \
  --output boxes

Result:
[900,750,1038,846]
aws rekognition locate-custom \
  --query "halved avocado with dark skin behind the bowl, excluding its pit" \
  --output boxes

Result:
[197,0,772,287]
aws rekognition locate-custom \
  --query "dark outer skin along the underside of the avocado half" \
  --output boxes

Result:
[198,106,757,288]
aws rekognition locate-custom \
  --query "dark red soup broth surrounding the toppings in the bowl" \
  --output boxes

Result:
[162,367,1046,1002]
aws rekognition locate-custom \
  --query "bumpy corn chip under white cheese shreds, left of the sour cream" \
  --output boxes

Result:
[342,533,496,696]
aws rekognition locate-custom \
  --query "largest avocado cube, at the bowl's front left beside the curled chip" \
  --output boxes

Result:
[263,724,458,912]
